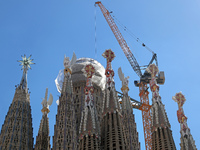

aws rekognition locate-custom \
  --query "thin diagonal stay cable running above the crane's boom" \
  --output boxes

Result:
[110,14,155,54]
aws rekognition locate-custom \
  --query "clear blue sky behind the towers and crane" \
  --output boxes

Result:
[0,0,200,150]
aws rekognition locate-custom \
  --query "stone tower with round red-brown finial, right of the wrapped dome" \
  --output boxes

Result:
[101,49,127,150]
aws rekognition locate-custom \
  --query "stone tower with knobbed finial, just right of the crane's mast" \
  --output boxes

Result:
[147,64,176,150]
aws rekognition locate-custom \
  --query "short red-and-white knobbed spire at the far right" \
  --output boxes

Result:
[172,92,197,150]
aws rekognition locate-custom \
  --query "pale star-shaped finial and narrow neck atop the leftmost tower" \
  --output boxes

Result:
[18,55,35,92]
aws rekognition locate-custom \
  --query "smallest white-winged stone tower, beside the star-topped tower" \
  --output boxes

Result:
[35,88,53,150]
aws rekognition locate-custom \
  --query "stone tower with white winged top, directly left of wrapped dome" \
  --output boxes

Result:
[53,54,77,150]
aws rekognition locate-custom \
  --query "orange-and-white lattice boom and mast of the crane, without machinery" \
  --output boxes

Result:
[95,1,152,150]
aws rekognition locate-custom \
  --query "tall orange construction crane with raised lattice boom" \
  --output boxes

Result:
[95,1,165,150]
